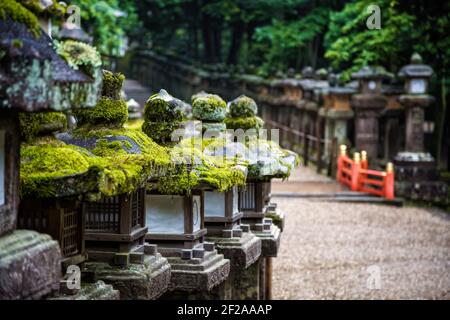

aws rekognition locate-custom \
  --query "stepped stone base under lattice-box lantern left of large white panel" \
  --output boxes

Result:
[82,253,170,300]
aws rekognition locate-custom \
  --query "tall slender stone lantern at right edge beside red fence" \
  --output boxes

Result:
[394,53,447,201]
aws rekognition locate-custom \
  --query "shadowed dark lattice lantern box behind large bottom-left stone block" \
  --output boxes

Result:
[18,197,87,269]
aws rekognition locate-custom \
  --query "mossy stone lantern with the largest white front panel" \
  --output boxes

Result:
[143,91,230,298]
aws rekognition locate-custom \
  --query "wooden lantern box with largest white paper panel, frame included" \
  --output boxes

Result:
[145,190,207,259]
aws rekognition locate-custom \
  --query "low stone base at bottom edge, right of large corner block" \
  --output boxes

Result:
[49,281,120,300]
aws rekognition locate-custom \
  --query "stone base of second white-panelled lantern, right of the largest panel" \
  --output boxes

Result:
[206,232,261,273]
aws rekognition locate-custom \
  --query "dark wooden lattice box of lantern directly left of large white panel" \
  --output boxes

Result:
[83,188,148,265]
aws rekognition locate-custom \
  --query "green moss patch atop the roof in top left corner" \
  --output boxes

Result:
[0,0,41,37]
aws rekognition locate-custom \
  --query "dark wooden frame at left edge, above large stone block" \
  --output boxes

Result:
[0,110,20,234]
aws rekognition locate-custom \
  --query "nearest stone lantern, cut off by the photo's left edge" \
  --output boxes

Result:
[0,0,104,299]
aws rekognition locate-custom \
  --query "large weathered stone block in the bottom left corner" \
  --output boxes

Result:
[0,230,61,300]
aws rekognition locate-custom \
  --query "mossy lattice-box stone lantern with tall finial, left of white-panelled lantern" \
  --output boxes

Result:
[53,70,172,299]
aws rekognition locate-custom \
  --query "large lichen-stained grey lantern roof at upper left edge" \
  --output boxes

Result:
[0,11,98,111]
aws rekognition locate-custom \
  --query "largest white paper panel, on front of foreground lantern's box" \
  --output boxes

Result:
[145,194,184,234]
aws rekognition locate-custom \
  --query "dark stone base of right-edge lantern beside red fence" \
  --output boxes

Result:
[394,152,448,202]
